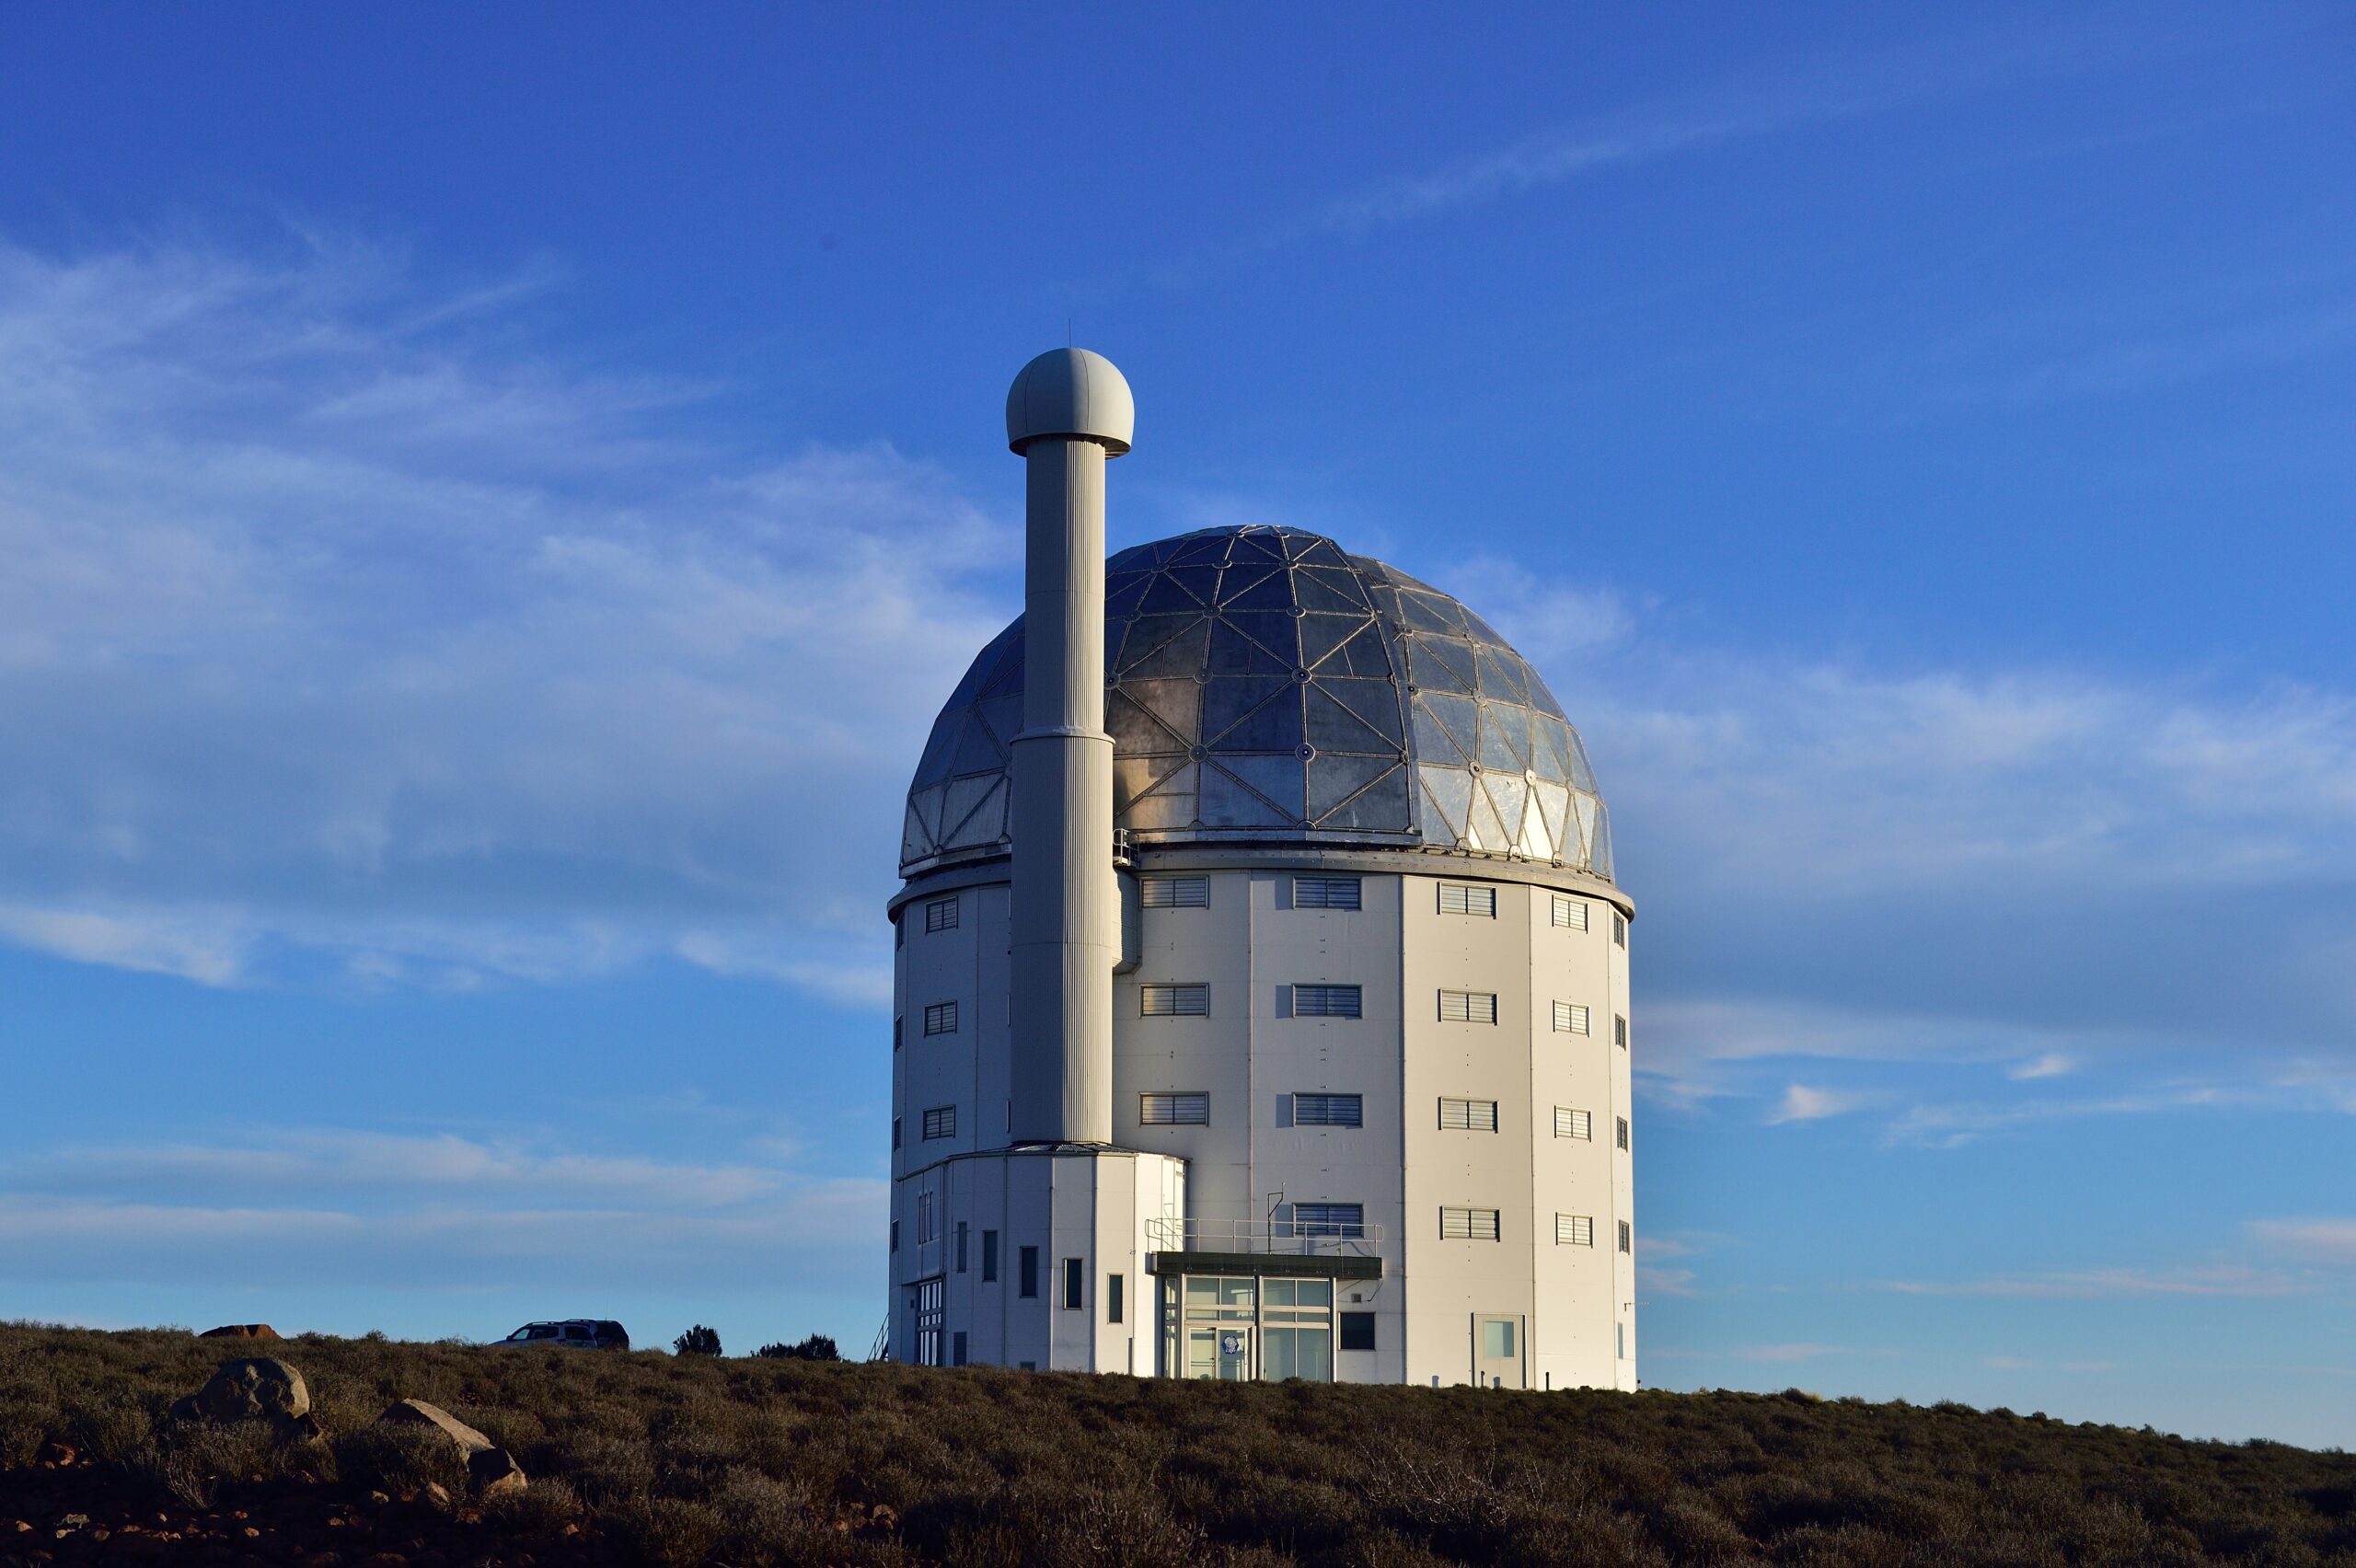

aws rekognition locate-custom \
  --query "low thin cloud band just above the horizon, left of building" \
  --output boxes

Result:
[0,1130,886,1290]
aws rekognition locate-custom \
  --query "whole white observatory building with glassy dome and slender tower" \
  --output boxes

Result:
[888,349,1635,1389]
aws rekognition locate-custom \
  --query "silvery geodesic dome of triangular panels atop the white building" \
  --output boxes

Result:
[900,525,1611,881]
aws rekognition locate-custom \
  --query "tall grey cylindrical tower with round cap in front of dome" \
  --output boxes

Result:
[1006,349,1136,1144]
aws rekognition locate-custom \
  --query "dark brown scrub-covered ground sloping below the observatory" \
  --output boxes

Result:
[0,1325,2356,1568]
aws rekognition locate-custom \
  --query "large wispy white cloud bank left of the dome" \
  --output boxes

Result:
[0,248,1013,1006]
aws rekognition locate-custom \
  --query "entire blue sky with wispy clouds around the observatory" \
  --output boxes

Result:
[0,5,2356,1443]
